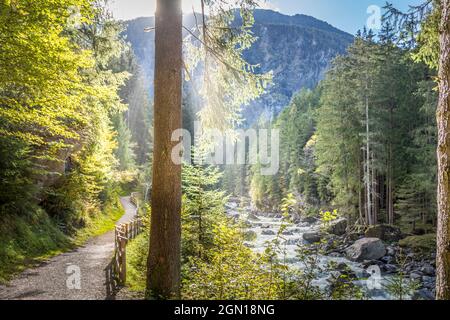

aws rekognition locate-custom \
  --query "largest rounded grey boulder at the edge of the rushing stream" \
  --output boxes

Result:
[345,238,386,262]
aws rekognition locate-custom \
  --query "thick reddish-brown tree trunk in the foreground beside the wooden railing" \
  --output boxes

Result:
[147,0,182,299]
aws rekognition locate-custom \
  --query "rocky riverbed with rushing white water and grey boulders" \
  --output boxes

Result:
[227,202,435,300]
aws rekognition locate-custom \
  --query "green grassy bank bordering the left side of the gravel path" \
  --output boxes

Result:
[0,200,124,283]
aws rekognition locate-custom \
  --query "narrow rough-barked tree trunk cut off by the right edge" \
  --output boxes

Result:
[436,0,450,300]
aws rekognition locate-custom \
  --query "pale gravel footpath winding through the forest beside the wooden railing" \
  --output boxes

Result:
[0,197,136,300]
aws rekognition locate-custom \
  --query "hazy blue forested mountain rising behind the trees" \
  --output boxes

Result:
[122,10,353,123]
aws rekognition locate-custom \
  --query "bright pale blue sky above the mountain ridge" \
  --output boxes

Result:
[110,0,423,34]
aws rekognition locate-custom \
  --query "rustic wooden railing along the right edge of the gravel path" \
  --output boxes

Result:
[112,218,143,285]
